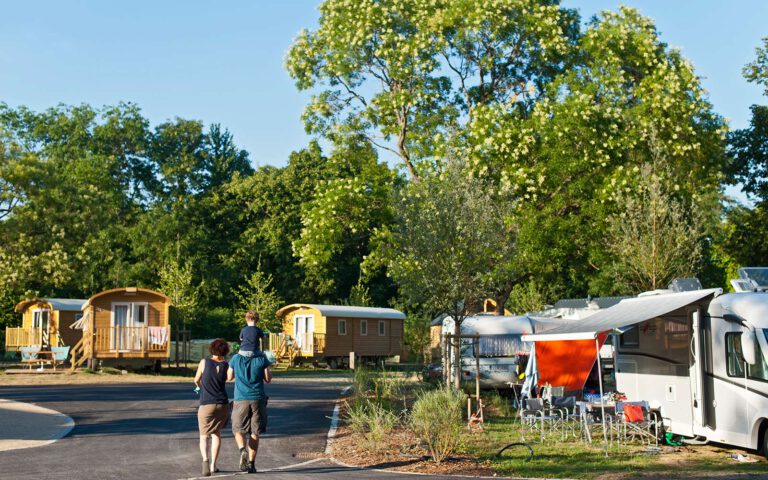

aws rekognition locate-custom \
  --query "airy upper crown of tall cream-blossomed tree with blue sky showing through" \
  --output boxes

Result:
[286,0,578,178]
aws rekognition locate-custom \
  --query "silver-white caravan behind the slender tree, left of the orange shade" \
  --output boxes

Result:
[442,314,533,388]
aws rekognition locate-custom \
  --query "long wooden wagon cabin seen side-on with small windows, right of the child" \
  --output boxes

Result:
[270,303,405,368]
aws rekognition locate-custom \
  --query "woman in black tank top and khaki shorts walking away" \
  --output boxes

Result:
[195,339,232,477]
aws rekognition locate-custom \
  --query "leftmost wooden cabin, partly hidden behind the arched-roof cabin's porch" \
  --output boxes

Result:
[5,298,86,352]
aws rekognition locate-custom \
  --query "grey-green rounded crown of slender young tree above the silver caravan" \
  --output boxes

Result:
[378,160,516,381]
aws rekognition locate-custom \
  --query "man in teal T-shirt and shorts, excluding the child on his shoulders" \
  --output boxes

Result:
[229,352,272,473]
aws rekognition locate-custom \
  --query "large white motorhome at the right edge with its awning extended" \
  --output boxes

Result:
[526,269,768,456]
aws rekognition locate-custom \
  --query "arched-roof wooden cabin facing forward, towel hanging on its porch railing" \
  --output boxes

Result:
[72,287,171,369]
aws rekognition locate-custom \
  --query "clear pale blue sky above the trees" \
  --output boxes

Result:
[0,0,768,178]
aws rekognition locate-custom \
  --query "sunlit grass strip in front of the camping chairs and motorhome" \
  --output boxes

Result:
[462,418,768,479]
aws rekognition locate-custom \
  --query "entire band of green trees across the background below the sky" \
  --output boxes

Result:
[0,0,768,350]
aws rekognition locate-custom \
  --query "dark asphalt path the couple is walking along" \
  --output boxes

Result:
[0,377,476,480]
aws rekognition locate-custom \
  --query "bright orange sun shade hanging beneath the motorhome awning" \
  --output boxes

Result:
[536,333,608,391]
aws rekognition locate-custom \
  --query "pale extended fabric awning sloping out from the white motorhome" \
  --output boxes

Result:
[522,288,722,342]
